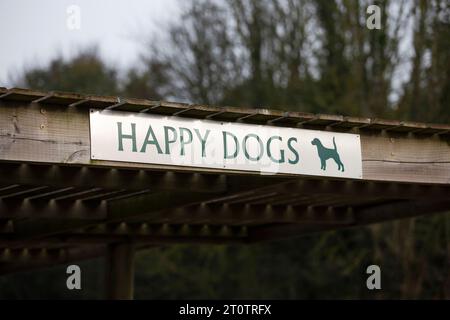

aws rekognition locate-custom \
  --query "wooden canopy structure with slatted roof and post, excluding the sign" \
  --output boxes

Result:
[0,88,450,298]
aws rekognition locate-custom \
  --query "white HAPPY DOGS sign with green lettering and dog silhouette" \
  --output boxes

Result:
[90,110,362,179]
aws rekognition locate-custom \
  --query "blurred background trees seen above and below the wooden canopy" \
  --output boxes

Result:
[0,0,450,299]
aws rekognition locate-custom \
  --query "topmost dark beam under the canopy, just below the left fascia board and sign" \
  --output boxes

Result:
[0,162,226,194]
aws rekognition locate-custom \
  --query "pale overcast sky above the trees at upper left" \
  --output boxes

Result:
[0,0,180,87]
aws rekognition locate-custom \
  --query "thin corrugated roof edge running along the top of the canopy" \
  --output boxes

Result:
[0,87,450,135]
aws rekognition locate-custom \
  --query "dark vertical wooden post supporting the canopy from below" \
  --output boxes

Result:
[105,243,135,300]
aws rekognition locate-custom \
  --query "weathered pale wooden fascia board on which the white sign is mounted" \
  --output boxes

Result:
[0,101,450,184]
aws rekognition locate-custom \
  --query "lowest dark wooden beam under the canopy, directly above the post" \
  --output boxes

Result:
[0,222,248,250]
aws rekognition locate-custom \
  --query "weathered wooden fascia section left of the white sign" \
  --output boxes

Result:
[0,102,90,163]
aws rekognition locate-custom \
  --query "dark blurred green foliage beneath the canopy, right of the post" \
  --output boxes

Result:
[136,214,450,299]
